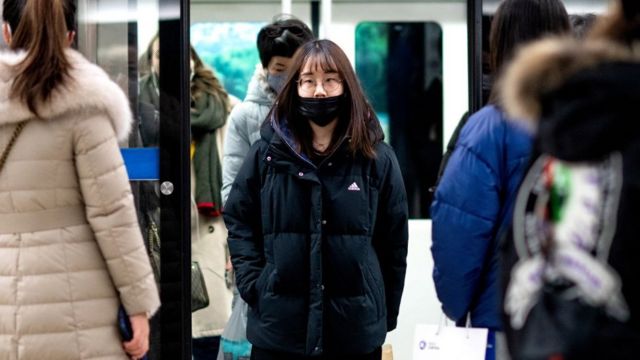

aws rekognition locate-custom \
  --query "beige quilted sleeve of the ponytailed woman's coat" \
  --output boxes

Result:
[73,114,160,314]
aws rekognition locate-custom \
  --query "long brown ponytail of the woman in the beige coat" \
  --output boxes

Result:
[2,0,75,116]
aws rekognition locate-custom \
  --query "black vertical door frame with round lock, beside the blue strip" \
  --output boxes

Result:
[159,0,191,359]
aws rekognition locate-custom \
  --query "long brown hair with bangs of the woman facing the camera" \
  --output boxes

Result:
[267,40,384,158]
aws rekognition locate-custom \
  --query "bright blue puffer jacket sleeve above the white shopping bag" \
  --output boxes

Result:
[431,131,500,321]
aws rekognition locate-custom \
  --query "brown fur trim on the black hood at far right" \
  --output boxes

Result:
[497,38,640,129]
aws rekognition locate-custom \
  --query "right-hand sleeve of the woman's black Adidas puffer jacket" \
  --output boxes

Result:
[373,145,409,331]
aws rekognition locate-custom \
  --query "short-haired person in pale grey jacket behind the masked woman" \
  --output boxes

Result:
[222,15,313,205]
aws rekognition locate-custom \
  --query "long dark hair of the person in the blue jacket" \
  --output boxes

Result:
[489,0,571,103]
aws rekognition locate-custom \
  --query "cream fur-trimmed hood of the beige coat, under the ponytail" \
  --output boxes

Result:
[0,49,132,140]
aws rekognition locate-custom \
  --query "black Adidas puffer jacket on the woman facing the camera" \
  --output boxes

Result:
[224,117,408,356]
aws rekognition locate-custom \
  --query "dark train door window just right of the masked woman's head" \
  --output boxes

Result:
[356,22,443,218]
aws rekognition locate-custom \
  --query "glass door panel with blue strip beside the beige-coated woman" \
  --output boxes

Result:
[77,0,161,360]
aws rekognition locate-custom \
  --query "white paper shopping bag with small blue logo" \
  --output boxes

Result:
[413,318,489,360]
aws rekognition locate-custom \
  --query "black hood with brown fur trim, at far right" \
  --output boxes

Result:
[499,39,640,161]
